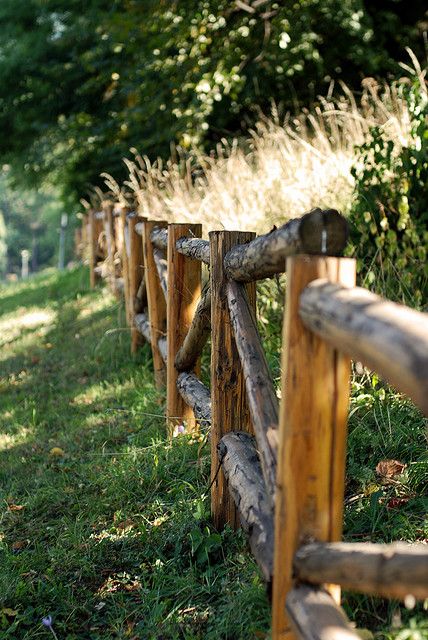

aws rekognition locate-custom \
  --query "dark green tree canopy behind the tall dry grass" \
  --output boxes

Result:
[0,0,426,202]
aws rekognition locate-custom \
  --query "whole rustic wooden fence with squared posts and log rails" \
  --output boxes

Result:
[77,203,428,640]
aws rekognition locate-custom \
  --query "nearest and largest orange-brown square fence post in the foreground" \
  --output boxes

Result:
[272,255,355,640]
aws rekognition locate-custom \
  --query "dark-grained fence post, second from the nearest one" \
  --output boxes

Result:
[209,231,256,529]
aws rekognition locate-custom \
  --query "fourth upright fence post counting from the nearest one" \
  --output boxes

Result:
[143,220,166,389]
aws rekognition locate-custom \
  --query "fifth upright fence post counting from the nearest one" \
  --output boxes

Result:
[128,213,144,353]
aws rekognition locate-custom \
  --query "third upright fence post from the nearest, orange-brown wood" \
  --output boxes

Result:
[166,223,202,434]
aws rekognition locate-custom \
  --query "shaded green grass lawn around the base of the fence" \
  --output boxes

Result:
[0,268,428,640]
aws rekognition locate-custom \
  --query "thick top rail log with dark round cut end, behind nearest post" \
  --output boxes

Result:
[224,209,348,282]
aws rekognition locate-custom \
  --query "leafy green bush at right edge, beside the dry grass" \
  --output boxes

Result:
[351,82,428,306]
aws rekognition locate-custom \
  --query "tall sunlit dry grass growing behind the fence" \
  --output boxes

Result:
[104,67,417,233]
